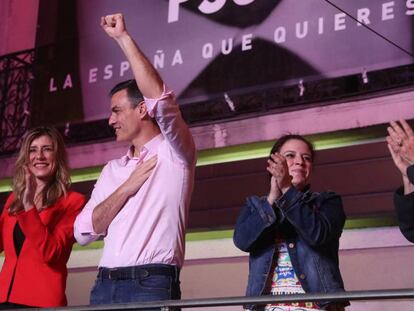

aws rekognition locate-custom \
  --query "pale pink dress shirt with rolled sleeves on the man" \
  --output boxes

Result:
[74,91,196,268]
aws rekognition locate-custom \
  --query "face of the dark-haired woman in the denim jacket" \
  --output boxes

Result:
[279,139,313,190]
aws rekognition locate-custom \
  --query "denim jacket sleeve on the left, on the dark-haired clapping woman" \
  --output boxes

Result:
[233,196,279,252]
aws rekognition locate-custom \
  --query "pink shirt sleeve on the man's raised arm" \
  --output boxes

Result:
[145,85,196,166]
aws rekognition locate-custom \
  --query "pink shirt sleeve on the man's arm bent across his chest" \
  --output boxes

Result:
[74,164,112,245]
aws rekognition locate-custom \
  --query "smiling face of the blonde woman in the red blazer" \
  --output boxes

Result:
[28,135,56,182]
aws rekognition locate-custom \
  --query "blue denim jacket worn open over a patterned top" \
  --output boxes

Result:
[233,187,349,310]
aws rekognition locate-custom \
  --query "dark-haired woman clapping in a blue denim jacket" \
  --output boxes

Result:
[233,135,349,311]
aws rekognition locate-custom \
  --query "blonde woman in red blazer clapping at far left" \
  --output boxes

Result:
[0,127,85,309]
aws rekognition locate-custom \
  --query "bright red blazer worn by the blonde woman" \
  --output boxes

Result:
[0,192,85,307]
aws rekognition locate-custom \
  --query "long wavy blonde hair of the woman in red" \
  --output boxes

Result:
[9,126,70,215]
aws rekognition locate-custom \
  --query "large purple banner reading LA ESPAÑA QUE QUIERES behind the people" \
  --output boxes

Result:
[33,0,414,124]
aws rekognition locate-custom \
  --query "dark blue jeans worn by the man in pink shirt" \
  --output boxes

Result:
[90,264,181,310]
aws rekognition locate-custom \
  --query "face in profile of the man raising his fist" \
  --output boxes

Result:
[109,89,141,141]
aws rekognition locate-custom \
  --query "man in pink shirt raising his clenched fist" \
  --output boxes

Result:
[75,14,196,304]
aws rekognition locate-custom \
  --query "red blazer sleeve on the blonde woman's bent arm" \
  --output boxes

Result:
[16,192,85,263]
